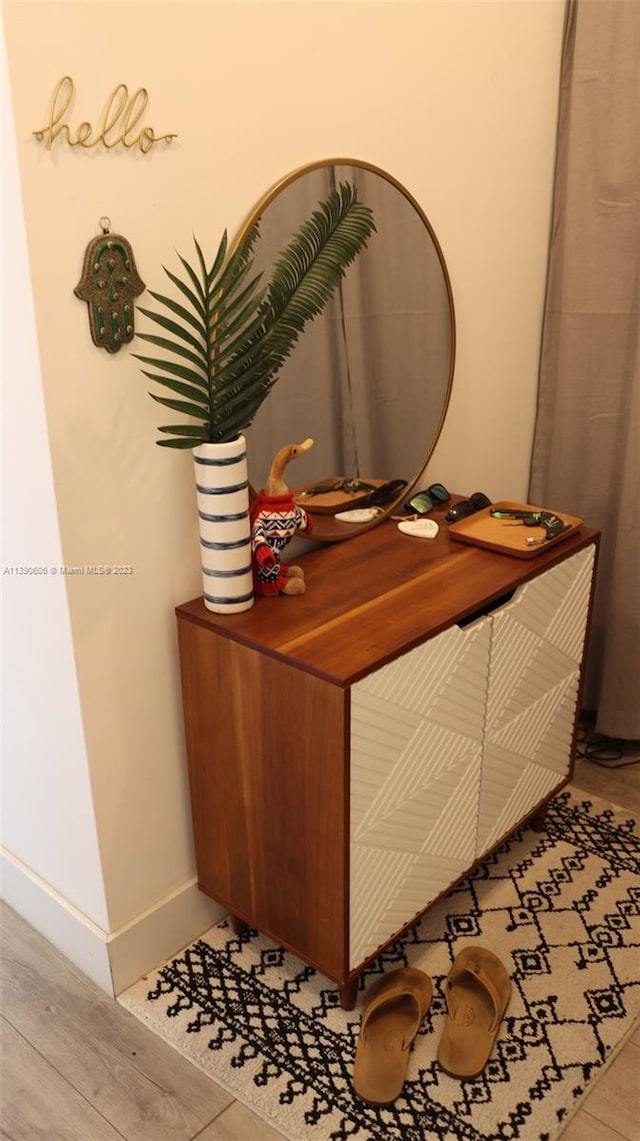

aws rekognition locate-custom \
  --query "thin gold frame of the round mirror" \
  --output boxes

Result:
[232,157,456,542]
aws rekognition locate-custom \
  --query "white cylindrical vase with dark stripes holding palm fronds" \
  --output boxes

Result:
[193,436,253,614]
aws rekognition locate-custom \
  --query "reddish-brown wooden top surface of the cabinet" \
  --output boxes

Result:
[176,512,599,686]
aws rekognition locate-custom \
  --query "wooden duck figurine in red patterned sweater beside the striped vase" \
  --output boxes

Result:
[249,439,314,594]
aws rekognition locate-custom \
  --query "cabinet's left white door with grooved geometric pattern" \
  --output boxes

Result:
[349,617,492,969]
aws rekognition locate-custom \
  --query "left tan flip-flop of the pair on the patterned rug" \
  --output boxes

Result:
[354,966,434,1106]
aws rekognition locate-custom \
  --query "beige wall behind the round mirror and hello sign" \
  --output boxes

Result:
[3,0,564,985]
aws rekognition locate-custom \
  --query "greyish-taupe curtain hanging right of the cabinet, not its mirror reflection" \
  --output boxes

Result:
[529,0,640,739]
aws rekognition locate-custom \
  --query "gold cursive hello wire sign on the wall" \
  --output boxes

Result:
[33,75,177,154]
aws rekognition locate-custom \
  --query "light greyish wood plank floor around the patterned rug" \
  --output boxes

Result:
[0,746,640,1141]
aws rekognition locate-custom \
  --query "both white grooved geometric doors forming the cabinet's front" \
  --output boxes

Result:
[349,547,594,968]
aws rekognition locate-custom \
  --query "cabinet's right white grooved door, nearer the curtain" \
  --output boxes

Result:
[477,547,596,856]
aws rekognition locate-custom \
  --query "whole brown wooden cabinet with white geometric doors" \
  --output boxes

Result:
[176,521,599,1009]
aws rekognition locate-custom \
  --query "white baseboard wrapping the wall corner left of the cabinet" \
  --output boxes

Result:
[0,851,225,997]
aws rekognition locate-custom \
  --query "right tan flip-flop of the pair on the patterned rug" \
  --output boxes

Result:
[438,946,511,1078]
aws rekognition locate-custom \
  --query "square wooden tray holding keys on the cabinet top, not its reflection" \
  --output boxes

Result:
[448,500,583,559]
